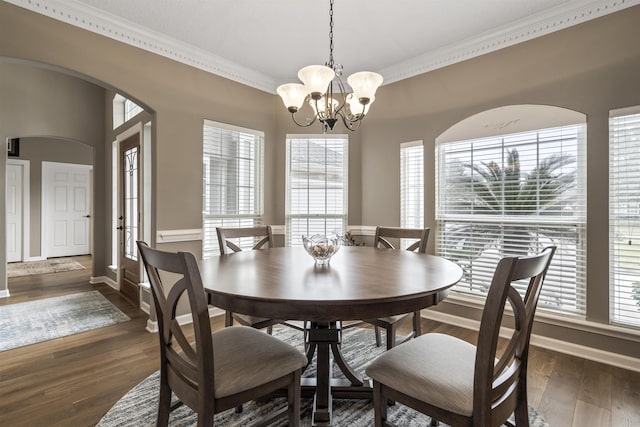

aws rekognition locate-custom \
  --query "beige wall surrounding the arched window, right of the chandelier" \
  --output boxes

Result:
[352,7,640,357]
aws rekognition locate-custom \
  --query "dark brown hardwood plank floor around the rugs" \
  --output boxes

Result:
[0,257,640,427]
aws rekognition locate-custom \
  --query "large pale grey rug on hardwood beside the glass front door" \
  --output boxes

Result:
[0,291,131,351]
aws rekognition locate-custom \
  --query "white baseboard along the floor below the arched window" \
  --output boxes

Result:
[421,310,640,372]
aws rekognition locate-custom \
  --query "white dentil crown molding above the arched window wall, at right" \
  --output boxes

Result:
[379,0,640,84]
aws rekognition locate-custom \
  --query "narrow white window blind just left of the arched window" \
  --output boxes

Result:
[400,141,424,228]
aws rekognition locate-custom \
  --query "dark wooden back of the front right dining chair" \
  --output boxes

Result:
[473,246,556,425]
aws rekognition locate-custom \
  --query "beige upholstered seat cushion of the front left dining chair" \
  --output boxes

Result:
[212,326,307,398]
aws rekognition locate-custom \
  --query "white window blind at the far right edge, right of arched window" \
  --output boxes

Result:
[609,107,640,327]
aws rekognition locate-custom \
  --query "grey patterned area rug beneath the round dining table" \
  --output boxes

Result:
[97,328,549,427]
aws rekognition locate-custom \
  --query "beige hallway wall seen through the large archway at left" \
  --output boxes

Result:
[0,61,104,280]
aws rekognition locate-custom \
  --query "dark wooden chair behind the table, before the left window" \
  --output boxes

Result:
[216,225,283,335]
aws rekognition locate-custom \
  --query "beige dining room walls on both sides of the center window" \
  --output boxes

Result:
[0,3,640,357]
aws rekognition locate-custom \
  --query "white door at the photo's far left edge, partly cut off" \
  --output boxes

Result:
[6,163,23,262]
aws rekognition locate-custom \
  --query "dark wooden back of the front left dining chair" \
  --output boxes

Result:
[137,241,215,420]
